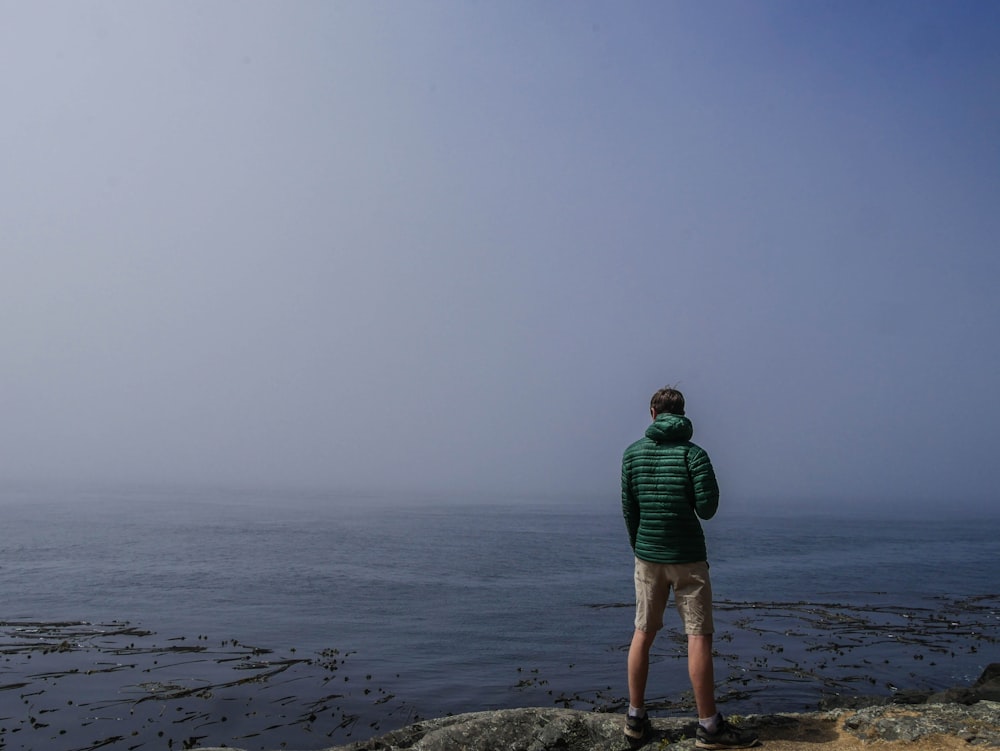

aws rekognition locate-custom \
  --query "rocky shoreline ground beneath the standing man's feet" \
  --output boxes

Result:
[191,663,1000,751]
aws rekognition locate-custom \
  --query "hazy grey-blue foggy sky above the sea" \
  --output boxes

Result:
[0,0,1000,509]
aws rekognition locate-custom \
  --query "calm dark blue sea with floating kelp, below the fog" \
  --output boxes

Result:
[0,488,1000,751]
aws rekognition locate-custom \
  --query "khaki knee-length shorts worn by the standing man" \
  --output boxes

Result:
[635,558,715,634]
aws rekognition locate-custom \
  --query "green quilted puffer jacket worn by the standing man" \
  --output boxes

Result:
[622,415,719,563]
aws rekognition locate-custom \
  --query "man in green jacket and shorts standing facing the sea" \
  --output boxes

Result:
[622,388,757,749]
